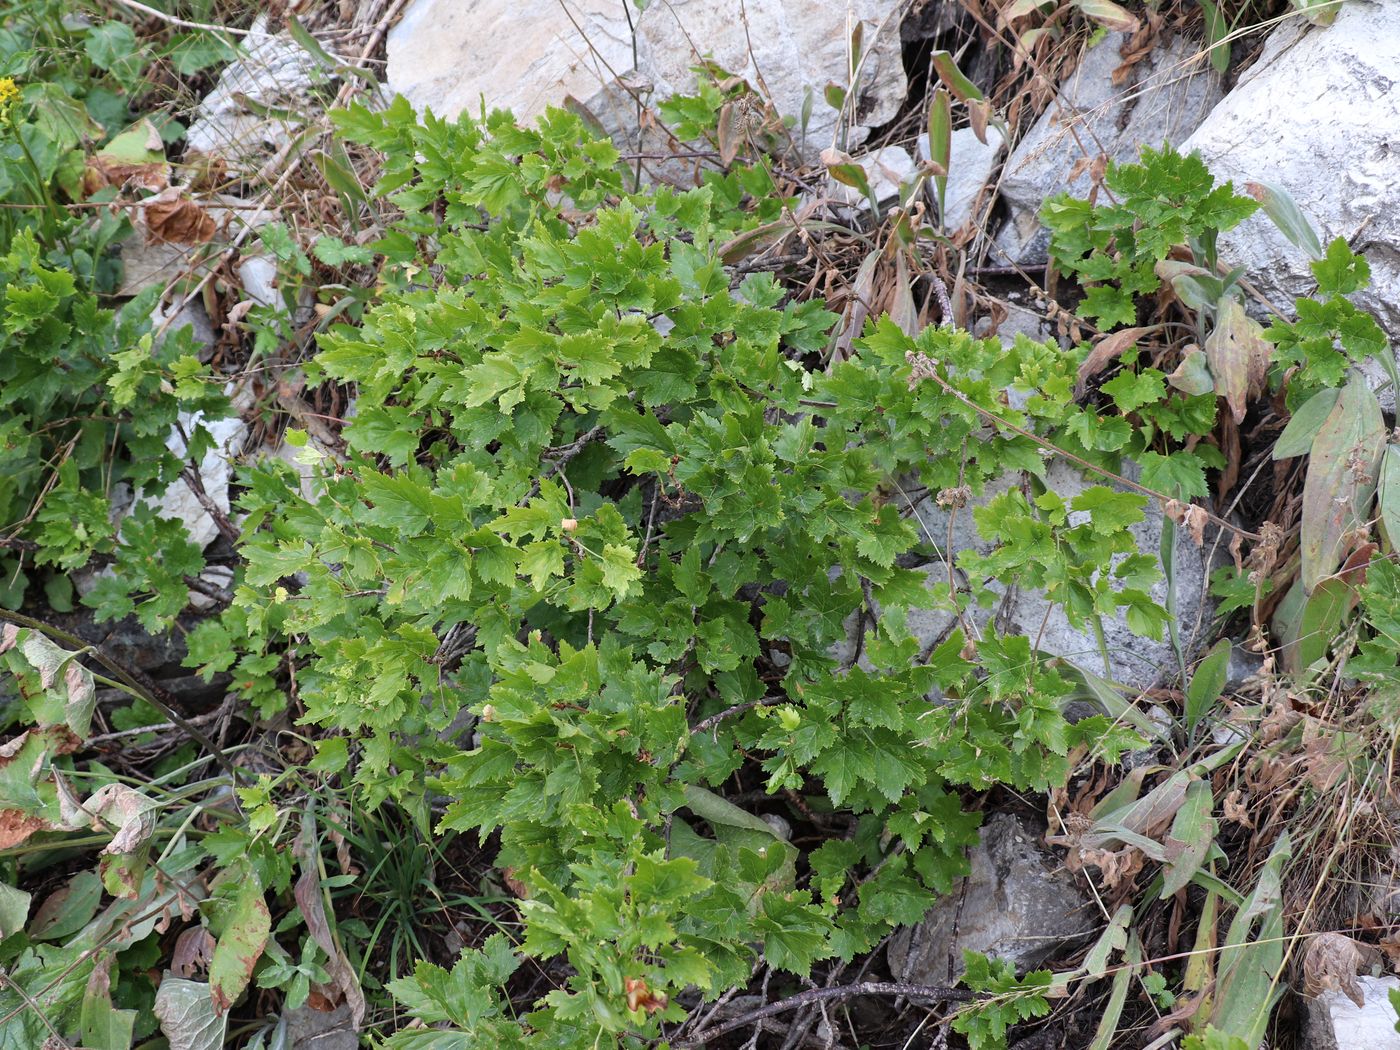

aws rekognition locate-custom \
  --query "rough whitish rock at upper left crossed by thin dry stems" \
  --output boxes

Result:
[185,17,325,174]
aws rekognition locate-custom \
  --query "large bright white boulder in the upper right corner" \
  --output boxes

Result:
[1182,0,1400,337]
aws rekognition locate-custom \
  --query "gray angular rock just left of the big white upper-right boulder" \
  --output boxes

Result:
[997,34,1226,266]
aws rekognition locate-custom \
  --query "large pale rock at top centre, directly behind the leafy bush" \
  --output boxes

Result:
[388,0,906,155]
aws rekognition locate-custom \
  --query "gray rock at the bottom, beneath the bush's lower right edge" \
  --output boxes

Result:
[889,813,1098,984]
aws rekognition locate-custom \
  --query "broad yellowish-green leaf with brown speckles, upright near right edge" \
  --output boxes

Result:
[1301,372,1386,594]
